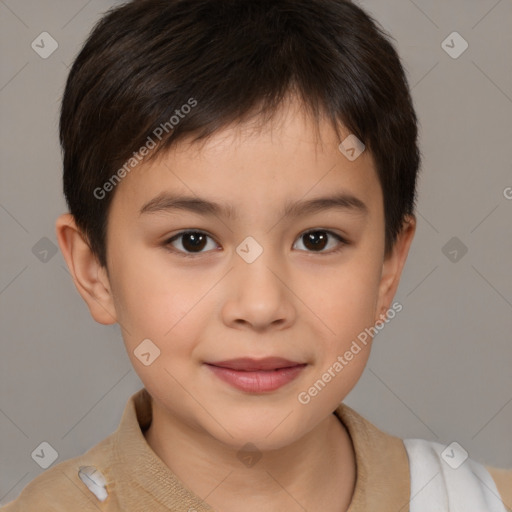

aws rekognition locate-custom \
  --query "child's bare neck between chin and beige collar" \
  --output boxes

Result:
[144,400,356,512]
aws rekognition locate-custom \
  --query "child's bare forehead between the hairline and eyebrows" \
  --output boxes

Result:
[112,99,382,221]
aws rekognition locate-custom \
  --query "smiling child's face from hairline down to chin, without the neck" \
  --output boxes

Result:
[75,98,407,449]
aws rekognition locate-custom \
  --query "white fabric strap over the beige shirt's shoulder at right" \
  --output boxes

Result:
[403,439,507,512]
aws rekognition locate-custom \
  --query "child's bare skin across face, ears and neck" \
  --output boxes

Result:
[56,100,416,512]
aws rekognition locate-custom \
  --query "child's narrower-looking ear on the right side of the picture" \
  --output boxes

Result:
[375,215,416,321]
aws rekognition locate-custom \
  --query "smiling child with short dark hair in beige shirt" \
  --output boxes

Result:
[3,0,512,512]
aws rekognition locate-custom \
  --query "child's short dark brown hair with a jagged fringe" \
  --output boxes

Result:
[60,0,420,267]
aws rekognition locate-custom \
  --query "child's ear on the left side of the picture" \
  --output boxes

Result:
[55,213,117,325]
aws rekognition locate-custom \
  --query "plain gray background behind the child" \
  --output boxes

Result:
[0,0,512,505]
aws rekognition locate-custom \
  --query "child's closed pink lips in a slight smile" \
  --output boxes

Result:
[206,357,307,393]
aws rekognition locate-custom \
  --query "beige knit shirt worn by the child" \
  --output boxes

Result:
[1,388,512,512]
